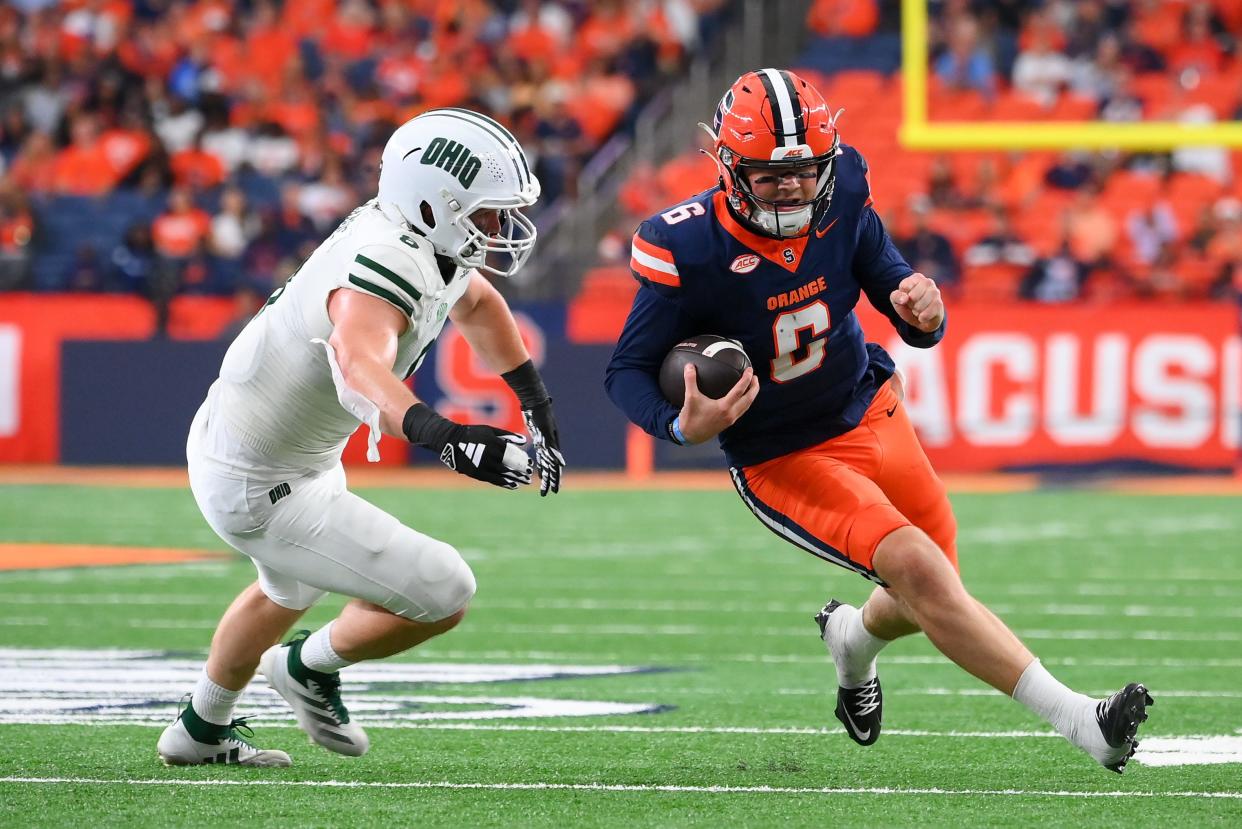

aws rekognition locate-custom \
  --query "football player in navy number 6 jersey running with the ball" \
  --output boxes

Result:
[606,68,1151,772]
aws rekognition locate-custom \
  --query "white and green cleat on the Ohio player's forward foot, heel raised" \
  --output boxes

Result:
[258,630,370,757]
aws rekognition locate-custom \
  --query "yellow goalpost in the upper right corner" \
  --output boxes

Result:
[899,0,1242,150]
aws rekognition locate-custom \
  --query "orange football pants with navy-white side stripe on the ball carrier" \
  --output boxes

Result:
[730,380,958,584]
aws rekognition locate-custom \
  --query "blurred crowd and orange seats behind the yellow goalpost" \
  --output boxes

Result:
[591,0,1242,308]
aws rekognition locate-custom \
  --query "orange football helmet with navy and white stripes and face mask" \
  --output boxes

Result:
[703,68,841,239]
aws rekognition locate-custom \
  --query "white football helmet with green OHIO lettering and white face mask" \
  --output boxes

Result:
[379,108,539,276]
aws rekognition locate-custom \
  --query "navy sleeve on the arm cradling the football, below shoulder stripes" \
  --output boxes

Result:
[604,283,693,440]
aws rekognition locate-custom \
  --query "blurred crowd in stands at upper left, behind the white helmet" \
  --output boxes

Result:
[0,0,728,328]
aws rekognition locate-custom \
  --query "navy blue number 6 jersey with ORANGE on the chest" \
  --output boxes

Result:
[605,145,944,466]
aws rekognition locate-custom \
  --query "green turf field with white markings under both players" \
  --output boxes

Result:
[0,479,1242,828]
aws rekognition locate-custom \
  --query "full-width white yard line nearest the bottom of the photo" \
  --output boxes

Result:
[0,777,1242,800]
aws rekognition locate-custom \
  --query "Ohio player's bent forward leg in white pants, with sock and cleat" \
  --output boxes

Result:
[247,467,474,756]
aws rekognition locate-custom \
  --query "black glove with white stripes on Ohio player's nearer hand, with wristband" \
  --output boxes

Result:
[402,403,533,490]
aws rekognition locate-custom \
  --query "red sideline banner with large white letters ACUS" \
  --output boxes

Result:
[863,303,1242,471]
